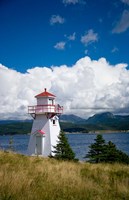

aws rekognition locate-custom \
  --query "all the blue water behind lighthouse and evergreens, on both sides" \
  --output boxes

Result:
[0,133,129,160]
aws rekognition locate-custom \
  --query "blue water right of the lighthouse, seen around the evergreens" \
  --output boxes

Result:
[68,133,129,160]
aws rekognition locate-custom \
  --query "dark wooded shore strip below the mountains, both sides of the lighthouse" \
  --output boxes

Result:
[0,118,129,135]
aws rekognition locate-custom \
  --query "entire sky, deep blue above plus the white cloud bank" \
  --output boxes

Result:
[0,0,129,119]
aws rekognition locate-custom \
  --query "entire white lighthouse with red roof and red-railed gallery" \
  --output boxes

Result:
[28,88,63,157]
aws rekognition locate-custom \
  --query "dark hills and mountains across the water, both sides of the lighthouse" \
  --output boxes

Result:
[0,112,129,135]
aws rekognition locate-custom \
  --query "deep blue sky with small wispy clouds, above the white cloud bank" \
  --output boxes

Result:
[0,0,129,73]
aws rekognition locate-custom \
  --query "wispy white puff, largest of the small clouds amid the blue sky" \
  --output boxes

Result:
[81,29,98,46]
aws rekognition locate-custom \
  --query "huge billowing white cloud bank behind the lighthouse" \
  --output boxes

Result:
[0,57,129,119]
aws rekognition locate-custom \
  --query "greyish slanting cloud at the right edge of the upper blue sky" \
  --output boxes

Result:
[112,10,129,33]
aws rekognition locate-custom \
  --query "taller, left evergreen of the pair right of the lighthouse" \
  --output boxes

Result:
[85,135,106,163]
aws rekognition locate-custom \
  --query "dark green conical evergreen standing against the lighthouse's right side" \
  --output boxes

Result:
[53,131,76,160]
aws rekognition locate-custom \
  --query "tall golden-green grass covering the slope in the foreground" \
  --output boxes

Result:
[0,152,129,200]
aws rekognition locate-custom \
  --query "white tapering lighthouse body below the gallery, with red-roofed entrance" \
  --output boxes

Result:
[28,115,60,157]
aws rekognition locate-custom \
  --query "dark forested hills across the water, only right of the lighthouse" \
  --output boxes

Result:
[62,112,129,132]
